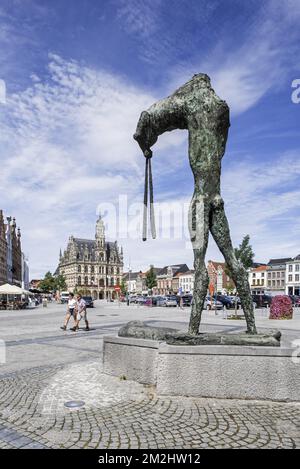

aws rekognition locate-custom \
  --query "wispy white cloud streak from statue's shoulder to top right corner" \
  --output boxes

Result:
[169,0,300,115]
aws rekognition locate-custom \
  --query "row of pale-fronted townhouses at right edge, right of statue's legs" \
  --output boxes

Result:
[249,255,300,295]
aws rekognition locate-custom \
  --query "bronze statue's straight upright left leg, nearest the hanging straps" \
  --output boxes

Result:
[189,194,209,335]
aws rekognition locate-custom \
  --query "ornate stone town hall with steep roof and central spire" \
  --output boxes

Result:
[57,217,123,299]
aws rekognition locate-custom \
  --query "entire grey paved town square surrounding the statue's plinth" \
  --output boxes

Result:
[0,302,300,449]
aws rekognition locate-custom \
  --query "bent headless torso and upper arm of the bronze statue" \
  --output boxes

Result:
[147,74,230,198]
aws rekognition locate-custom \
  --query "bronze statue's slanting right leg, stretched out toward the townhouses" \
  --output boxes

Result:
[210,197,257,334]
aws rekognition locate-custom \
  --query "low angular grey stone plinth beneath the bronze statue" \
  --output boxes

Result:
[103,336,300,401]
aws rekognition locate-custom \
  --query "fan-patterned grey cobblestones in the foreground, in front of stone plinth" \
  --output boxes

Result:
[0,360,300,449]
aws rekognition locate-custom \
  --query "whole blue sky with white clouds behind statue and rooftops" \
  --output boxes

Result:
[0,0,300,277]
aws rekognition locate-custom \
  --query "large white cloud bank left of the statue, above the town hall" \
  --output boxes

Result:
[0,55,162,276]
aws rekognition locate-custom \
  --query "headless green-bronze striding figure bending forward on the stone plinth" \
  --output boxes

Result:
[134,73,256,335]
